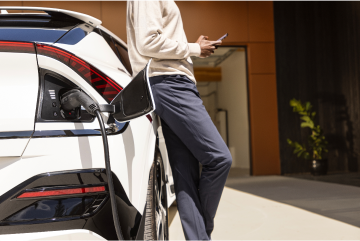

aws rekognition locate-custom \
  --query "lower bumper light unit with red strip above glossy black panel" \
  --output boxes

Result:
[0,185,108,223]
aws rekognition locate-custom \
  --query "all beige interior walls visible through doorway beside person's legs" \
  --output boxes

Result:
[197,48,250,169]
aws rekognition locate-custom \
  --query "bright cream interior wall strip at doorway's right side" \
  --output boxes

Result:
[217,49,250,169]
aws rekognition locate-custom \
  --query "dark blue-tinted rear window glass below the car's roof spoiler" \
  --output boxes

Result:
[0,28,67,43]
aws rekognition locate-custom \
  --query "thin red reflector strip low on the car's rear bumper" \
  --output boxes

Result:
[17,186,105,198]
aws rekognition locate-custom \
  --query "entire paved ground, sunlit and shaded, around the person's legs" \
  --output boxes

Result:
[169,176,360,241]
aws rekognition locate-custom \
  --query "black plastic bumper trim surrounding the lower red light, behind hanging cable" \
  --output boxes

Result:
[0,168,142,241]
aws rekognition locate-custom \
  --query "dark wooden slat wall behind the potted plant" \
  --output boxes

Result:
[274,0,360,173]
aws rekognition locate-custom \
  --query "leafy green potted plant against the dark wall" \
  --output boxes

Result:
[287,99,328,175]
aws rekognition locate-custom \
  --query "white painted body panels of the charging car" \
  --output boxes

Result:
[0,7,175,241]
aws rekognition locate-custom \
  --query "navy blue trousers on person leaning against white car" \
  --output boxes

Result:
[150,75,232,241]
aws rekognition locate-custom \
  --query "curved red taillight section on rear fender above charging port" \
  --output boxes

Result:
[36,44,123,103]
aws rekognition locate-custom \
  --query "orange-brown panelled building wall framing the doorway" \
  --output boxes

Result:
[0,0,280,175]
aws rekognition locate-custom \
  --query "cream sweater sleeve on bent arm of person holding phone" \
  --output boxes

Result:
[133,0,201,59]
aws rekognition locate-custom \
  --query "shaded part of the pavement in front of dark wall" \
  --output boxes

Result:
[227,176,360,227]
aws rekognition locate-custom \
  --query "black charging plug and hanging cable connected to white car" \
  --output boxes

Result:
[60,89,125,241]
